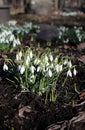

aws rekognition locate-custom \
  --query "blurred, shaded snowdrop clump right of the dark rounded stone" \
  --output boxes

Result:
[56,26,85,46]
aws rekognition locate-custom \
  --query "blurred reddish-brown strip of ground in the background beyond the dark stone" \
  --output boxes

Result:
[11,12,85,27]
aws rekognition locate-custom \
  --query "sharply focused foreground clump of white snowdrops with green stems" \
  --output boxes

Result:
[3,48,77,101]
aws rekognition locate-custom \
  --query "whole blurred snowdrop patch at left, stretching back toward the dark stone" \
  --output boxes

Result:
[0,21,39,51]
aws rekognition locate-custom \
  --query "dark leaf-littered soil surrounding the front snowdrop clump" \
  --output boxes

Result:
[0,13,85,130]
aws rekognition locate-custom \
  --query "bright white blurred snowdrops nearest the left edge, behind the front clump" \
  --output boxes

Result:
[0,25,21,51]
